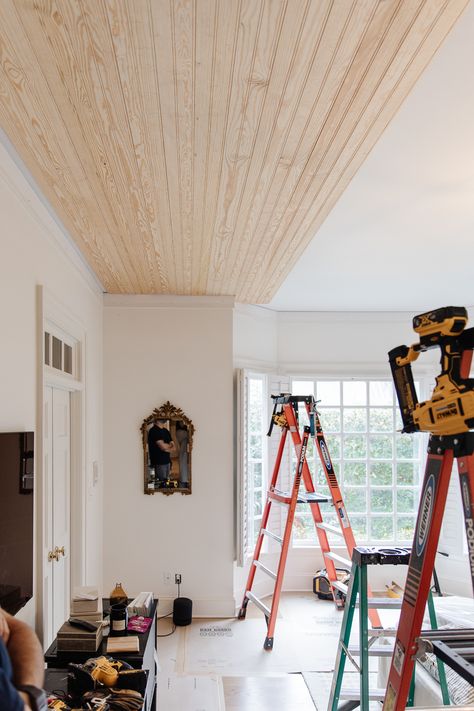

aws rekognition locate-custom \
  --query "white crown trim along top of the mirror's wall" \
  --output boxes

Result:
[104,294,234,309]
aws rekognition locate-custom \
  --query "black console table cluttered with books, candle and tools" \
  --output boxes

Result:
[44,598,158,711]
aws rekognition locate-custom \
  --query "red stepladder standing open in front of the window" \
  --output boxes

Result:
[238,394,381,650]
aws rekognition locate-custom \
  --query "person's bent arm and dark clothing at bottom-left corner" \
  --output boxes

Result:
[0,609,47,711]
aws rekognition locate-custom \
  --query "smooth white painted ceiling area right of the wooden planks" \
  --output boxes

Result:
[269,0,474,312]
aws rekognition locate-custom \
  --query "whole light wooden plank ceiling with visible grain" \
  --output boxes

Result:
[0,0,468,303]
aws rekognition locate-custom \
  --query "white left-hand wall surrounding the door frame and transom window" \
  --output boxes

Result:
[0,138,102,624]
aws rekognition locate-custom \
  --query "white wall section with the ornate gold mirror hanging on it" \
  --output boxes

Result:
[104,295,234,616]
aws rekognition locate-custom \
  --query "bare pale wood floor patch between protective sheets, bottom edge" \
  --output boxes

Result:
[222,674,315,711]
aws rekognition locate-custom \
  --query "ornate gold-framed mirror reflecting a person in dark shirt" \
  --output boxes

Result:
[140,401,194,495]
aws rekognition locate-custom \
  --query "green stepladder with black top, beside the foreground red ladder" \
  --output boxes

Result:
[328,546,450,711]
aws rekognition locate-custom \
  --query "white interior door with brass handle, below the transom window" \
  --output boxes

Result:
[43,387,71,646]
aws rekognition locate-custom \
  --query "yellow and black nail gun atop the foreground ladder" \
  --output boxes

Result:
[388,306,474,435]
